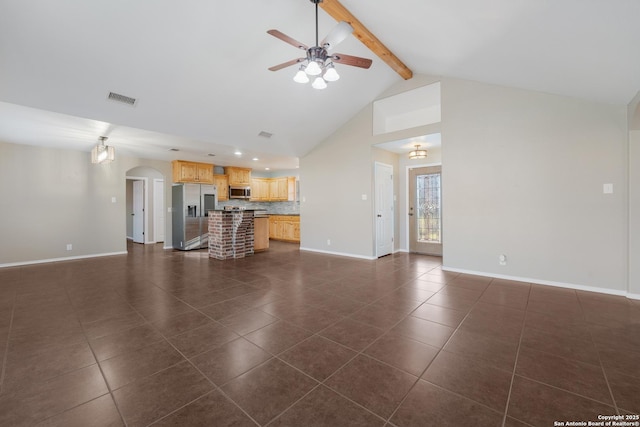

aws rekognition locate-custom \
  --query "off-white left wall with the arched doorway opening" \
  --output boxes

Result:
[0,142,171,266]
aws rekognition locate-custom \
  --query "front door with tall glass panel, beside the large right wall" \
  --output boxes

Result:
[409,166,442,256]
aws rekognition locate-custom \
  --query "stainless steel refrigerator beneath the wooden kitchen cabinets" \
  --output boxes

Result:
[171,184,218,251]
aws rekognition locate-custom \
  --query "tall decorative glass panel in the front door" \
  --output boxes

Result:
[416,173,442,243]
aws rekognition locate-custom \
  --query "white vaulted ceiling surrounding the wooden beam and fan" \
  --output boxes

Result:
[0,0,640,169]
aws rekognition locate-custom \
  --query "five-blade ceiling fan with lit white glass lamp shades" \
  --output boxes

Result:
[267,0,372,89]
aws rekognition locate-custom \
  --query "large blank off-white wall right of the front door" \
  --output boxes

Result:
[442,80,627,293]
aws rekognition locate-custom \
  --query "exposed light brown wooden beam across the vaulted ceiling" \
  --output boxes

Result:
[320,0,413,80]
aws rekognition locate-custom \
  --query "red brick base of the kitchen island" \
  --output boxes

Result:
[209,210,254,260]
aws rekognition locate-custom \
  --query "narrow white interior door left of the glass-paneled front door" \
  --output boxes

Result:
[374,162,393,258]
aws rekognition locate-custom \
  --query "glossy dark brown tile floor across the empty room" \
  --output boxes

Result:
[0,242,640,426]
